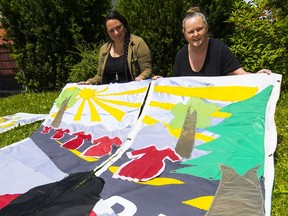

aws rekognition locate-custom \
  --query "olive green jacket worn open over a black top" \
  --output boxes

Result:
[88,35,152,84]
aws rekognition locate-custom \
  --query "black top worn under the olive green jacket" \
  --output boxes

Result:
[103,54,132,84]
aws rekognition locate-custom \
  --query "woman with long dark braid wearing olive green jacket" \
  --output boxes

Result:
[78,10,152,85]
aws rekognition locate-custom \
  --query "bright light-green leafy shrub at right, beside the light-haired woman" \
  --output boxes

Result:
[228,0,288,89]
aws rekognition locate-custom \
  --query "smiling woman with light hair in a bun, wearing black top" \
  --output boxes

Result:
[173,7,271,76]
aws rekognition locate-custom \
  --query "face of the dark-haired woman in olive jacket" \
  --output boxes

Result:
[106,19,126,43]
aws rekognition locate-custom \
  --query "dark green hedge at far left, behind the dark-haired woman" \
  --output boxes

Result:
[0,0,111,90]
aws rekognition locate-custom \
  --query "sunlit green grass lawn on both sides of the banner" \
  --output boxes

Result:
[0,92,288,216]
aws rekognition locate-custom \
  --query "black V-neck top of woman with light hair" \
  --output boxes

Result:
[173,38,241,76]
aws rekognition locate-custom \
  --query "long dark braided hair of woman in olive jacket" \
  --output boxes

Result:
[104,10,133,79]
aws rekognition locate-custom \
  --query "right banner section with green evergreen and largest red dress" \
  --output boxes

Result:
[99,75,281,216]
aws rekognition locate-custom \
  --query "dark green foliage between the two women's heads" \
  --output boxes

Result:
[117,0,188,76]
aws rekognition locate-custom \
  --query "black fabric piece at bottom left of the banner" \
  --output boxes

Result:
[0,172,104,216]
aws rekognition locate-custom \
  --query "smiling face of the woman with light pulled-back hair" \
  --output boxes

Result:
[184,16,208,47]
